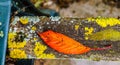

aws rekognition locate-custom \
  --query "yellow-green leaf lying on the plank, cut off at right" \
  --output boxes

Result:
[88,29,120,41]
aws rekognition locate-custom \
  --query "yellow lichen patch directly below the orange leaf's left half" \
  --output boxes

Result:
[34,42,55,58]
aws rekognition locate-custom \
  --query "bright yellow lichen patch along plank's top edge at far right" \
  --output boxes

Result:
[87,17,120,28]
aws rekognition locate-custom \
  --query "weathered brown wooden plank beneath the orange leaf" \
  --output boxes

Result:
[9,17,120,61]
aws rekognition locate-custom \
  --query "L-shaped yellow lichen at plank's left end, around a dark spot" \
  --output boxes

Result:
[8,32,26,48]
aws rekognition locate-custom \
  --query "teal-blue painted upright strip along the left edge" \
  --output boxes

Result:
[0,0,11,65]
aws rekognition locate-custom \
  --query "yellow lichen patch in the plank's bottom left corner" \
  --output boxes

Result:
[10,49,27,58]
